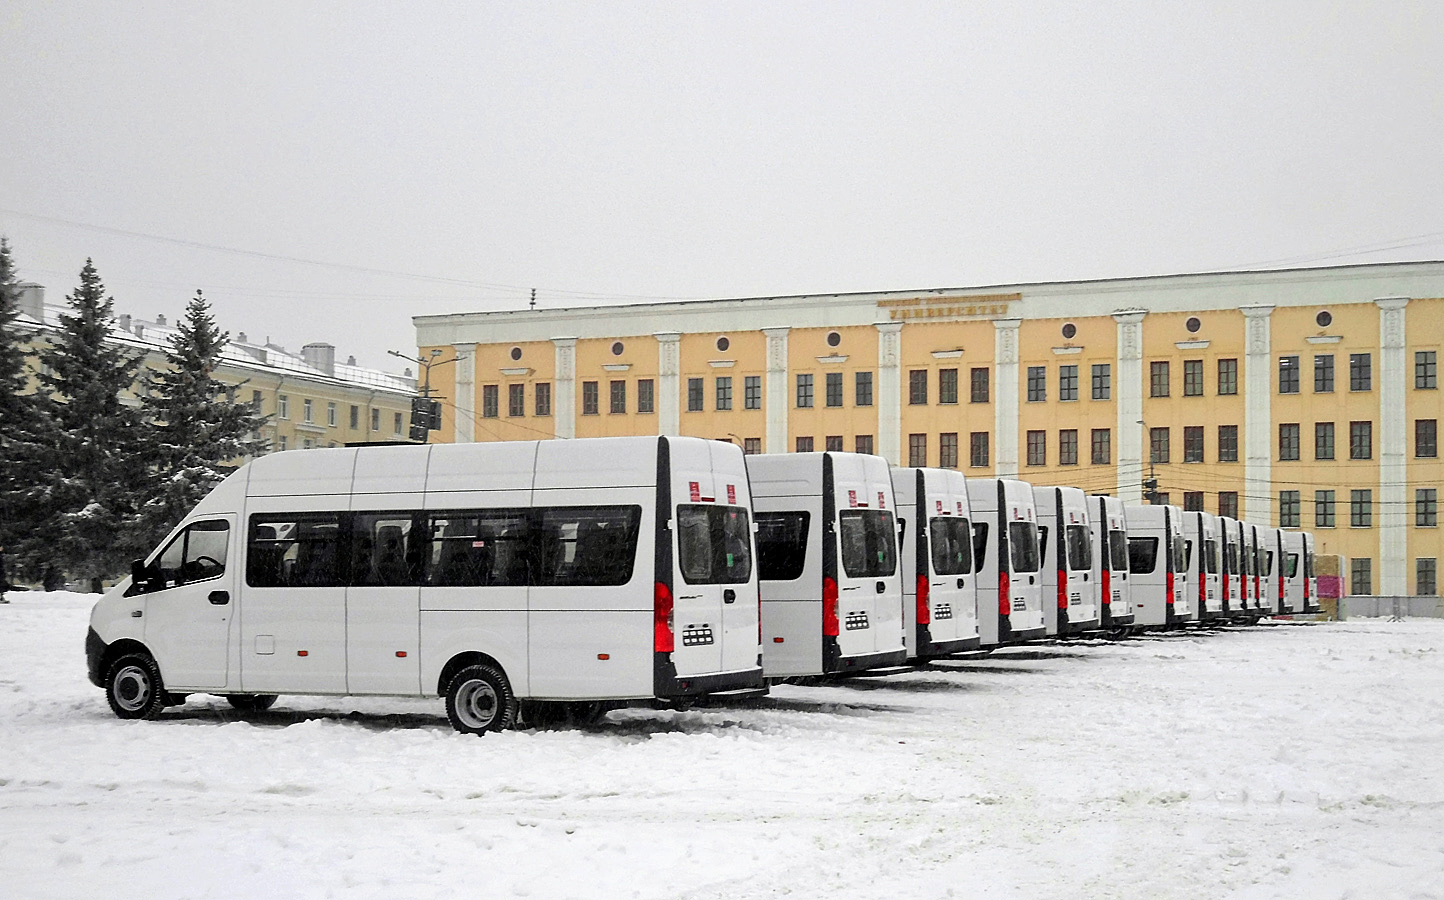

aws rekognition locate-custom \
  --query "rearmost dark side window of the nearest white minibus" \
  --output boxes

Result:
[533,506,641,587]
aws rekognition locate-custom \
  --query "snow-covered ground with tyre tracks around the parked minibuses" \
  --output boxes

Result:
[0,594,1444,900]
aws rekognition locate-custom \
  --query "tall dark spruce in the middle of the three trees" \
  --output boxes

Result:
[31,260,147,585]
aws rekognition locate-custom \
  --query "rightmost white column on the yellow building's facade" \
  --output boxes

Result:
[1375,298,1414,597]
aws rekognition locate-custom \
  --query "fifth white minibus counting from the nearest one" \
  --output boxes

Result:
[1032,487,1099,637]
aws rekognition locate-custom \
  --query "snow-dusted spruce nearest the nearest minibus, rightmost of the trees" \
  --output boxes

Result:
[127,290,261,555]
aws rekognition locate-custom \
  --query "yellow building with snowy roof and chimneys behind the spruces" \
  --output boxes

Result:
[14,283,416,451]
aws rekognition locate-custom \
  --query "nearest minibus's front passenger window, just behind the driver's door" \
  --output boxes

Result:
[245,513,345,588]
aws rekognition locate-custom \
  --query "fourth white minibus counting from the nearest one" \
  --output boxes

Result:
[967,478,1047,647]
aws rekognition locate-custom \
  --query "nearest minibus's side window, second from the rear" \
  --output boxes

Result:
[423,510,530,588]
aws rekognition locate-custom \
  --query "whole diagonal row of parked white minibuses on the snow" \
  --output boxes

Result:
[85,436,1317,734]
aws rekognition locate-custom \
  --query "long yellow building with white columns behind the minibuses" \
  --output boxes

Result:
[414,261,1444,595]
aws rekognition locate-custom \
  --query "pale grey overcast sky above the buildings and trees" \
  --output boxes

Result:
[0,0,1444,368]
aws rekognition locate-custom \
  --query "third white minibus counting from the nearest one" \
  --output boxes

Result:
[892,468,978,659]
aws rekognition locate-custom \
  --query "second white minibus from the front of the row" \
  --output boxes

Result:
[747,451,907,678]
